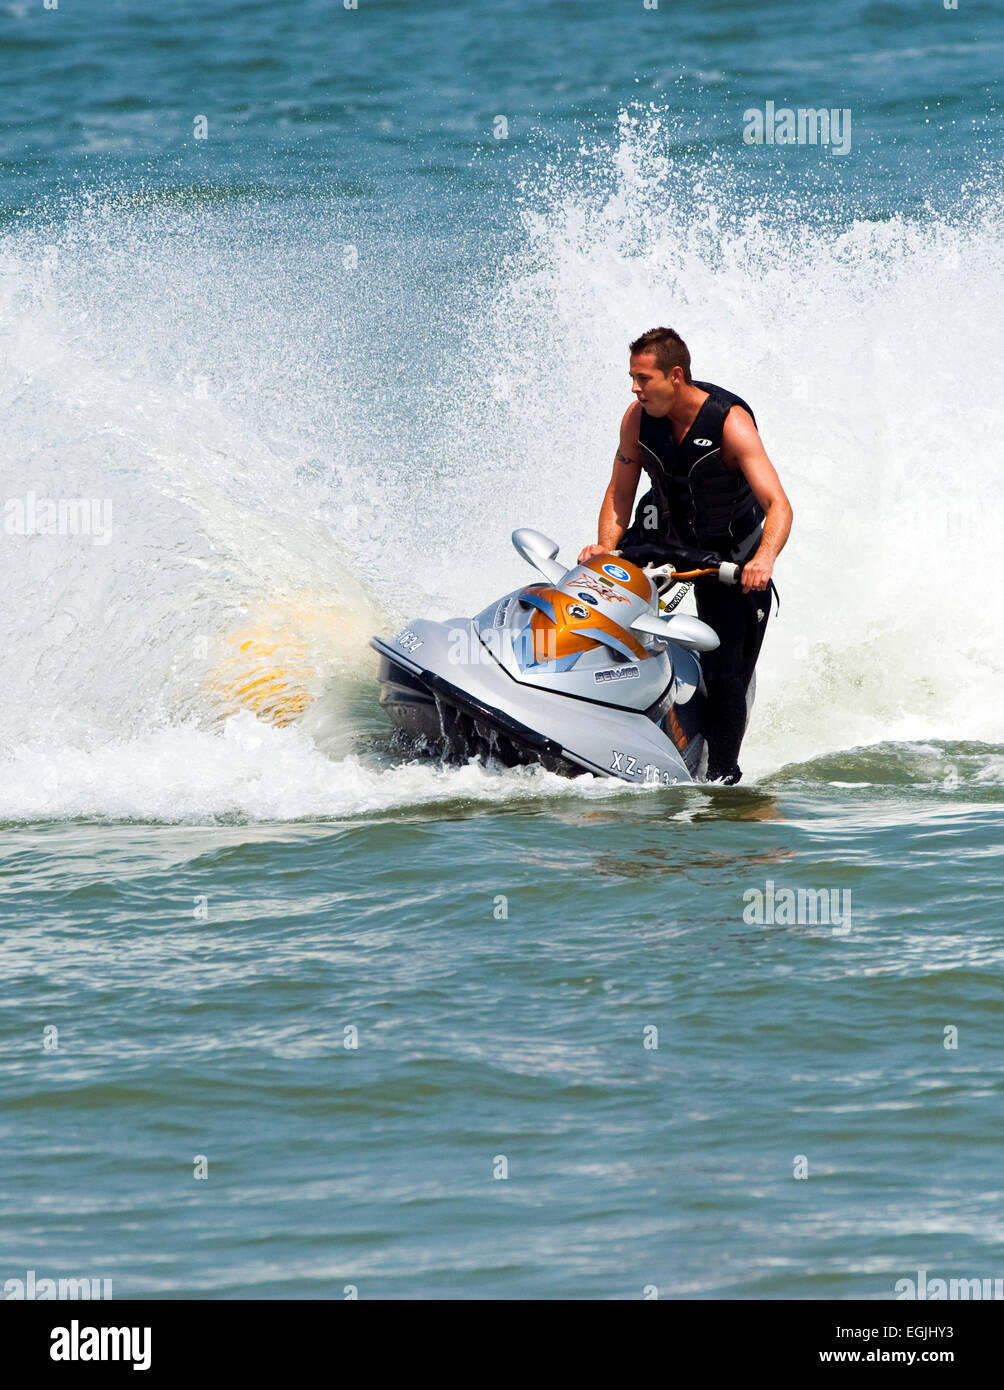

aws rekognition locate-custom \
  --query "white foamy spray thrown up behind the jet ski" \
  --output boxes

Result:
[0,114,1004,820]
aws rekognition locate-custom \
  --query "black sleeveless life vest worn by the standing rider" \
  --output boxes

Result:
[633,381,763,559]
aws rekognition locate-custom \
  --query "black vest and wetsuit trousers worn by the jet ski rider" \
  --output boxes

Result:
[619,381,770,783]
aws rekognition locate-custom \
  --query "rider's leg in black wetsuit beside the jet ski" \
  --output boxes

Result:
[694,580,770,783]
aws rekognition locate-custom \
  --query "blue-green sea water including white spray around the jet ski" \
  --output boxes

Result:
[0,0,1004,1298]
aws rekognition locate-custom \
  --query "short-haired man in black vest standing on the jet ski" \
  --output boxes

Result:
[578,328,793,785]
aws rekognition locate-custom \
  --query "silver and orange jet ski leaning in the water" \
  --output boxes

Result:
[370,528,752,785]
